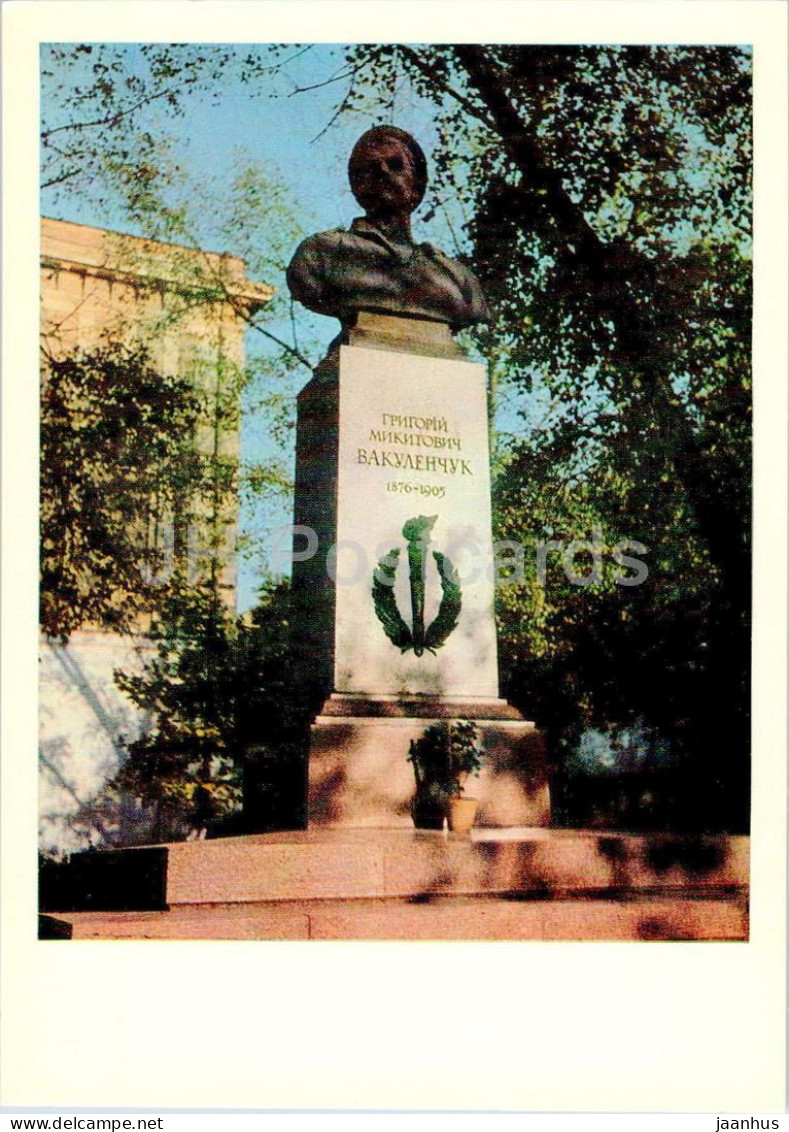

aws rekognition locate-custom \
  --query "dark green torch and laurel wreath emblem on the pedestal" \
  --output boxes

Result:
[372,515,461,657]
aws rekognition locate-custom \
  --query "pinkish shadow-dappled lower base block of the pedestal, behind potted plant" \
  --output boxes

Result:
[308,695,550,829]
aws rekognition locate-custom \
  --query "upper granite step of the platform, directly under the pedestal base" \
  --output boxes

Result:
[41,829,748,914]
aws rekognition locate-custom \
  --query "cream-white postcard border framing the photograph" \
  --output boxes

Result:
[2,0,787,1112]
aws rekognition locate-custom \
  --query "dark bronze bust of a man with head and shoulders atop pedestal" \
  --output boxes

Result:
[288,126,490,331]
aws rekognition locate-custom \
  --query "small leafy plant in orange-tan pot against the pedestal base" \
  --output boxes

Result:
[409,719,483,832]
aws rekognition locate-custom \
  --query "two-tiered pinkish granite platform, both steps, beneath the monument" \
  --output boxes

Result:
[42,829,748,940]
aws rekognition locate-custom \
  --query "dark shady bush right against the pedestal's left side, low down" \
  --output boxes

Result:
[114,583,306,830]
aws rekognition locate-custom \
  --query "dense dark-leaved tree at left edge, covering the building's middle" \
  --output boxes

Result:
[40,343,210,641]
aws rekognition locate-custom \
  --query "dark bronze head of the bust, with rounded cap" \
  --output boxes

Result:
[348,126,427,220]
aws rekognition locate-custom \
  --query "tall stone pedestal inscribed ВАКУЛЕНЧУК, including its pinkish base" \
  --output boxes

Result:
[293,316,549,826]
